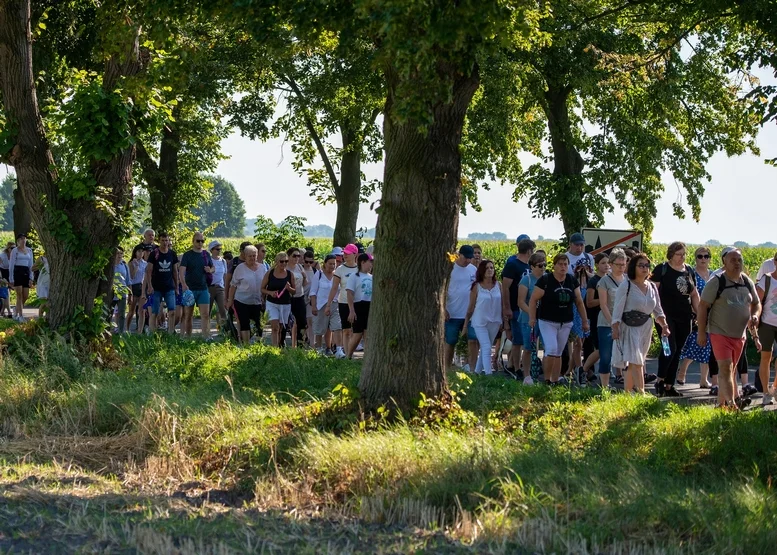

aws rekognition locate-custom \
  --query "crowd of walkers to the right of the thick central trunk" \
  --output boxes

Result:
[445,233,777,410]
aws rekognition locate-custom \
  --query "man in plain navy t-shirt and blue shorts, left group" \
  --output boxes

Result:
[178,231,216,341]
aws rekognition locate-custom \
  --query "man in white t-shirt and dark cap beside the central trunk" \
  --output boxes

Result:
[445,245,478,369]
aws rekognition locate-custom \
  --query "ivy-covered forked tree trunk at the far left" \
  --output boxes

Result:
[0,0,141,328]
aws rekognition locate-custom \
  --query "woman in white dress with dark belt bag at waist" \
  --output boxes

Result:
[612,253,669,393]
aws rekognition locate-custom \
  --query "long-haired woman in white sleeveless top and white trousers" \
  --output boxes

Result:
[463,260,502,376]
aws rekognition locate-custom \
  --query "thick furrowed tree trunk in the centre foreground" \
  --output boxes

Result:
[359,64,480,411]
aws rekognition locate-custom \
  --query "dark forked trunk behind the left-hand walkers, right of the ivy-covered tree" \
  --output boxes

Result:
[138,123,181,231]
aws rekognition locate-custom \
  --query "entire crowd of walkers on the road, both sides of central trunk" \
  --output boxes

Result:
[0,224,777,408]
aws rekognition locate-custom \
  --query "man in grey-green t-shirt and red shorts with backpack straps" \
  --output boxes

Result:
[697,248,761,410]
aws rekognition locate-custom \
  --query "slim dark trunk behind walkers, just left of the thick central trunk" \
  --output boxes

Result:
[333,131,362,247]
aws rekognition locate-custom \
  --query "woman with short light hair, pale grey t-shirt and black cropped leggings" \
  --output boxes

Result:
[226,245,267,345]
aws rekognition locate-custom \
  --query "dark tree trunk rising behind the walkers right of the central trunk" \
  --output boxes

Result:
[545,86,588,237]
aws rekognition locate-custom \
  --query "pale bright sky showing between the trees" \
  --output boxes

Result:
[218,123,777,244]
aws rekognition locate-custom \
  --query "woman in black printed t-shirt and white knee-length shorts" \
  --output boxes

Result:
[529,254,589,385]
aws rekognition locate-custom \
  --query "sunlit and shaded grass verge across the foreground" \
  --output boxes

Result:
[0,330,777,554]
